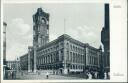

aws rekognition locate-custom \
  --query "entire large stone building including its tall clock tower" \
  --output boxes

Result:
[20,8,101,74]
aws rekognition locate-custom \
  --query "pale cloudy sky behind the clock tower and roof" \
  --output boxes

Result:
[3,3,104,60]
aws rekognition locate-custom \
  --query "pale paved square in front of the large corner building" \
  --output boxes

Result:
[6,72,108,80]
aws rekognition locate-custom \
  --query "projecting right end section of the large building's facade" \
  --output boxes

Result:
[85,44,101,71]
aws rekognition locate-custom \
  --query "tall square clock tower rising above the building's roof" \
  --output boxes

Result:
[33,8,49,47]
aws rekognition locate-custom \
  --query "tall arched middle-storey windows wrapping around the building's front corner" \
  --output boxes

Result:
[37,50,85,64]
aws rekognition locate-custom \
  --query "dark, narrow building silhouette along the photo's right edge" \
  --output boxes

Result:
[101,4,110,72]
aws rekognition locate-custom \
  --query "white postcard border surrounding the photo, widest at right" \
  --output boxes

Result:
[1,0,127,83]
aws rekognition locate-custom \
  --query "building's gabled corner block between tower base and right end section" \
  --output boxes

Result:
[37,34,85,73]
